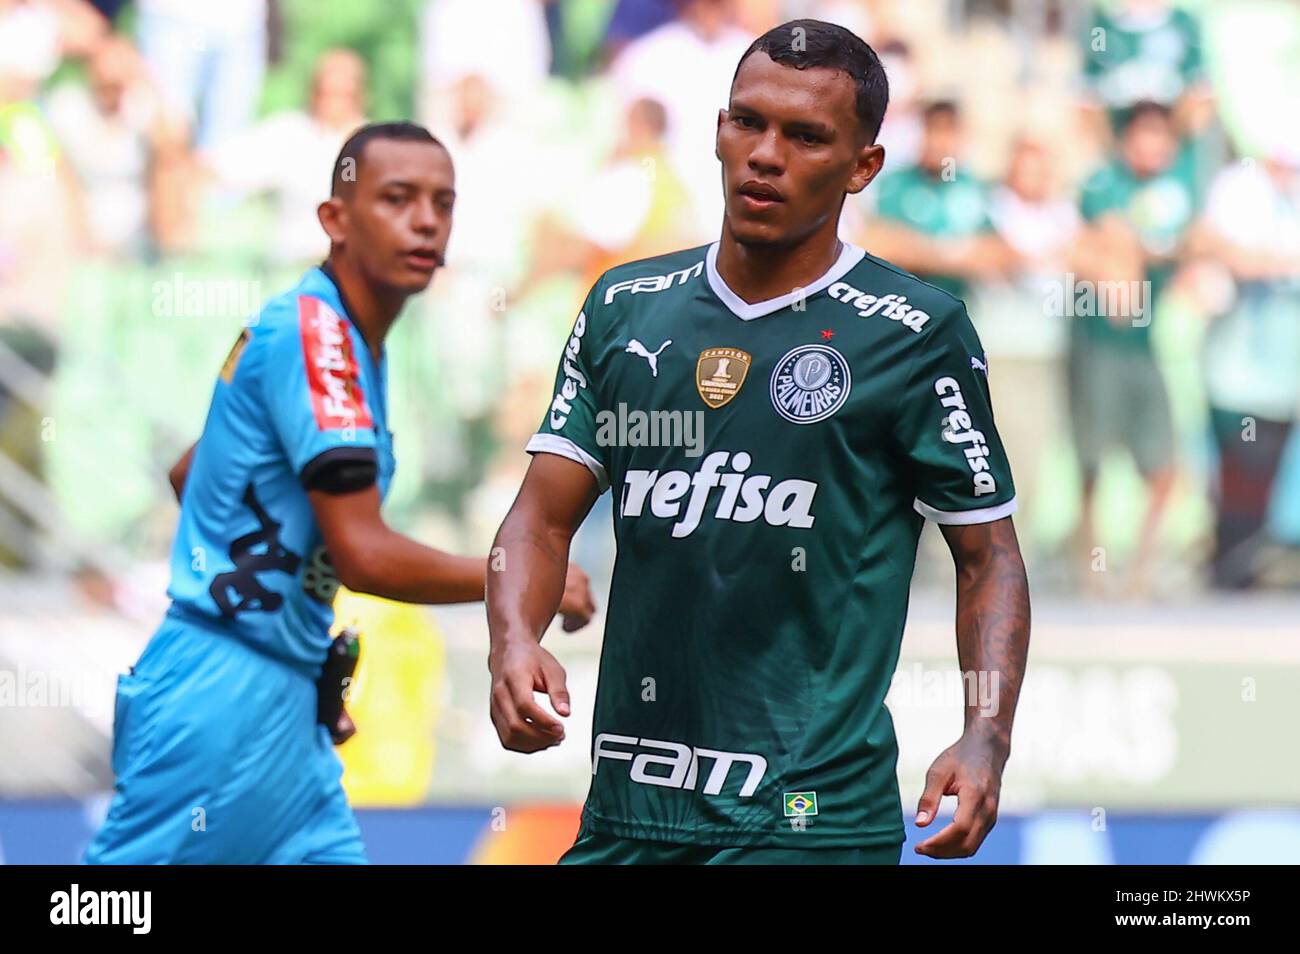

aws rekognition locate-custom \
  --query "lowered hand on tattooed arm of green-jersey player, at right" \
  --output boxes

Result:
[917,733,1006,858]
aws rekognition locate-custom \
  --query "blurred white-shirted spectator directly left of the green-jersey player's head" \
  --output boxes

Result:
[610,0,754,242]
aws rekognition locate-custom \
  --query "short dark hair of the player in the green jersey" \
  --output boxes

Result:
[732,19,889,142]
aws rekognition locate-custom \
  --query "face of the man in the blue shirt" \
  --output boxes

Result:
[335,139,456,292]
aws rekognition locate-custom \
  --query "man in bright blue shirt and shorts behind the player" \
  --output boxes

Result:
[86,123,594,864]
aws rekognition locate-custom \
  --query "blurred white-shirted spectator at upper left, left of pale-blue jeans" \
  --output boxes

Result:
[47,35,168,259]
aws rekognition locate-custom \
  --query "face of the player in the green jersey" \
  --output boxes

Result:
[716,52,884,244]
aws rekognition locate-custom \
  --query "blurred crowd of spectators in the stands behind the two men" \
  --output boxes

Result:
[0,0,1300,605]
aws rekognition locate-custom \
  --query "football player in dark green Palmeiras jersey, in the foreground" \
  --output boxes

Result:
[488,19,1030,863]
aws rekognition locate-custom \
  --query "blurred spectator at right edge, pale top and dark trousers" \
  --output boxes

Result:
[1199,142,1300,589]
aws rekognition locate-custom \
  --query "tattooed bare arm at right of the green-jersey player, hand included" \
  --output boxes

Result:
[917,517,1030,858]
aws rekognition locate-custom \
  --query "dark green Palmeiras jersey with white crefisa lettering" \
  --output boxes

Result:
[528,244,1015,847]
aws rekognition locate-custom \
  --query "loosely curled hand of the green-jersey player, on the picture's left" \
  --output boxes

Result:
[488,642,569,753]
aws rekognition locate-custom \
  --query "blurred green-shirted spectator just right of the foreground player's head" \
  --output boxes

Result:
[866,100,1014,299]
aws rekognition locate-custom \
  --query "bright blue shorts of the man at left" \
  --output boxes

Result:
[86,619,365,864]
